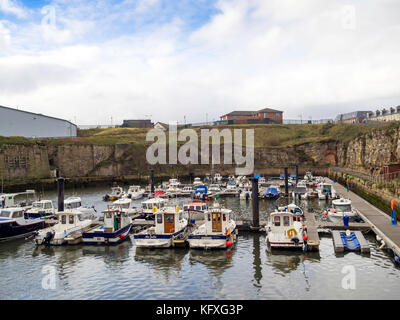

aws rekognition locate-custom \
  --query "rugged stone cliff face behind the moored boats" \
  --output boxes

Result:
[0,128,400,181]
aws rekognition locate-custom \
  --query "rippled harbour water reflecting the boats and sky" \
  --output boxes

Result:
[0,188,400,299]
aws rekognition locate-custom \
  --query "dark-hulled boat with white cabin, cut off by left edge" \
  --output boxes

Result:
[0,207,45,241]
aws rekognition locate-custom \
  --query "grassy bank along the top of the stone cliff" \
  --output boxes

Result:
[0,124,394,148]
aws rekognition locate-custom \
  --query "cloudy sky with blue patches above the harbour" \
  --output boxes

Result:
[0,0,400,125]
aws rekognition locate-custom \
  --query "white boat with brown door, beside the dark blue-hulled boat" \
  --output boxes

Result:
[134,206,188,248]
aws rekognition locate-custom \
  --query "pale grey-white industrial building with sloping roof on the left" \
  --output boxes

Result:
[0,106,77,138]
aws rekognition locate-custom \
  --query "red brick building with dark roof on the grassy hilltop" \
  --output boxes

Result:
[220,108,283,123]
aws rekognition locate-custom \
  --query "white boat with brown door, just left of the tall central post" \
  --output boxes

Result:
[188,202,237,249]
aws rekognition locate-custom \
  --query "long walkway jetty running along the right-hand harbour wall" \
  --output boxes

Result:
[329,176,400,256]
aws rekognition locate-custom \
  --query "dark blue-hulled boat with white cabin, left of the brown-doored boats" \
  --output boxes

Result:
[82,205,132,245]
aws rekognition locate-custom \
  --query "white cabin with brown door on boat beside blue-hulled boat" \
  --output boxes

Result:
[155,206,184,234]
